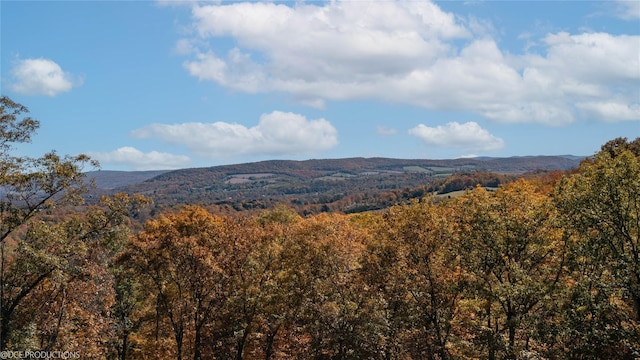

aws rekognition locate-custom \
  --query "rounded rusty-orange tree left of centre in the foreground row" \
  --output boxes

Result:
[120,206,236,360]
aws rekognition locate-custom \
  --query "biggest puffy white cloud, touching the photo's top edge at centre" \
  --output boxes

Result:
[185,1,470,95]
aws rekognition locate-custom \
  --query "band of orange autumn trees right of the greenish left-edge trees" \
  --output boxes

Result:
[118,136,640,359]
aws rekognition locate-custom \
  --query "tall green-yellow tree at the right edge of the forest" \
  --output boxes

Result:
[554,138,640,358]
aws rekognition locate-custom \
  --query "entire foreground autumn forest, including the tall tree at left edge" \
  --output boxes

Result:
[0,97,640,360]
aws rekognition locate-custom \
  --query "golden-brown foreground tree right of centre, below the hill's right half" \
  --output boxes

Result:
[363,198,466,359]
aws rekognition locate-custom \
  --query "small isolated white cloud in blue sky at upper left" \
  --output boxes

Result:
[10,58,82,96]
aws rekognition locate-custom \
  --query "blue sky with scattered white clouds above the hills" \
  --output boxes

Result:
[0,0,640,170]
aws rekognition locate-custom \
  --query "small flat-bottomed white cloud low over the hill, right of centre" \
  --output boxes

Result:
[409,121,504,151]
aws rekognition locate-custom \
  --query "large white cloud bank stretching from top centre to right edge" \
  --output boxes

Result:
[177,1,640,125]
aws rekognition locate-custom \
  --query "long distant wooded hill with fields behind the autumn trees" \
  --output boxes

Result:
[88,156,583,217]
